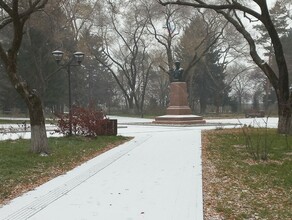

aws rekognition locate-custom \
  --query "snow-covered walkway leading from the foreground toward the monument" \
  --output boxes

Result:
[0,118,278,220]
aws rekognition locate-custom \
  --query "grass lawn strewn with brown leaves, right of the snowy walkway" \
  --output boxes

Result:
[202,128,292,220]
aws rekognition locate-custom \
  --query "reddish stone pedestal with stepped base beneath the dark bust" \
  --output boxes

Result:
[153,82,206,124]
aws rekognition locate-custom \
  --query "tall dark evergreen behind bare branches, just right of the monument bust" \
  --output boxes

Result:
[176,12,228,113]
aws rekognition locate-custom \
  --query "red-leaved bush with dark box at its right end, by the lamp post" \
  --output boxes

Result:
[57,107,117,137]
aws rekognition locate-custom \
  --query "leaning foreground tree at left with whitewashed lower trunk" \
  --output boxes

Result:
[0,0,48,153]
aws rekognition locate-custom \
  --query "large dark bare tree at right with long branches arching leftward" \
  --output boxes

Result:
[159,0,292,134]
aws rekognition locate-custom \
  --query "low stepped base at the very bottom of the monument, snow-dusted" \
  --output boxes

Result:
[153,115,206,125]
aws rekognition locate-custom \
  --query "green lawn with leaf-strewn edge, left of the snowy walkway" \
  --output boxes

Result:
[0,136,129,204]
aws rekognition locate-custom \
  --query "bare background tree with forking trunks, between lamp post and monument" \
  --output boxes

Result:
[95,2,153,115]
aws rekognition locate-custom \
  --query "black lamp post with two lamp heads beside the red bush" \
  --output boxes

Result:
[52,50,84,135]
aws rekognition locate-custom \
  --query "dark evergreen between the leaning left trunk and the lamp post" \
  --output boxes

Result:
[19,22,68,110]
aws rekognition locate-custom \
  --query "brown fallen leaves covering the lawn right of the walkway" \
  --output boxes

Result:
[202,130,292,220]
